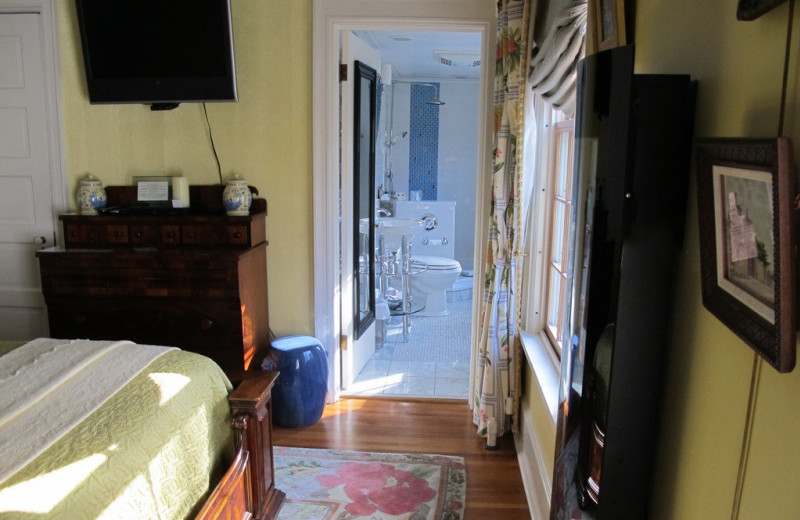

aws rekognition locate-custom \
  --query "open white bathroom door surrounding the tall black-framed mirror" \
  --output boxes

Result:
[340,31,381,390]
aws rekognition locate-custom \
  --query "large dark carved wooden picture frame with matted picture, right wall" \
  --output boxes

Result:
[695,137,797,372]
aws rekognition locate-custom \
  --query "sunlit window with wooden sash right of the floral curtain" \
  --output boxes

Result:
[522,96,575,357]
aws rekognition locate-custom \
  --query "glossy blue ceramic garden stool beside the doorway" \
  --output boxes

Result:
[272,336,328,428]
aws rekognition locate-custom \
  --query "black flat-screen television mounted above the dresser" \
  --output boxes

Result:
[76,0,237,109]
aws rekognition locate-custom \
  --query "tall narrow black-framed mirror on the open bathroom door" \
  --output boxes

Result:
[353,61,377,339]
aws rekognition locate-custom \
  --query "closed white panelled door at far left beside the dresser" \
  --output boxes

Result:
[0,13,60,340]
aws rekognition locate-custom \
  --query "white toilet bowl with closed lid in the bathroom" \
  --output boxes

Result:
[409,255,461,316]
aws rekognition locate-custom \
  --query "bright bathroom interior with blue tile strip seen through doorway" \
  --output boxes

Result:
[342,28,482,399]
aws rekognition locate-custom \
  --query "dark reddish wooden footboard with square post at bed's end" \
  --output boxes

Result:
[196,372,285,520]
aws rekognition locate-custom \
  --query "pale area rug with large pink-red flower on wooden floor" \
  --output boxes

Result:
[273,446,467,520]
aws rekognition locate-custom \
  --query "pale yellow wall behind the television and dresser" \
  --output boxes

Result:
[56,0,313,336]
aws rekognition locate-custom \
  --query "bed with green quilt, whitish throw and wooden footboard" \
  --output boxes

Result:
[0,339,284,520]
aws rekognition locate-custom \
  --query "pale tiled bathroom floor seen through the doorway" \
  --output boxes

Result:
[345,299,472,399]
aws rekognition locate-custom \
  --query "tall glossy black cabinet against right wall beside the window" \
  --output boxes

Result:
[551,46,696,520]
